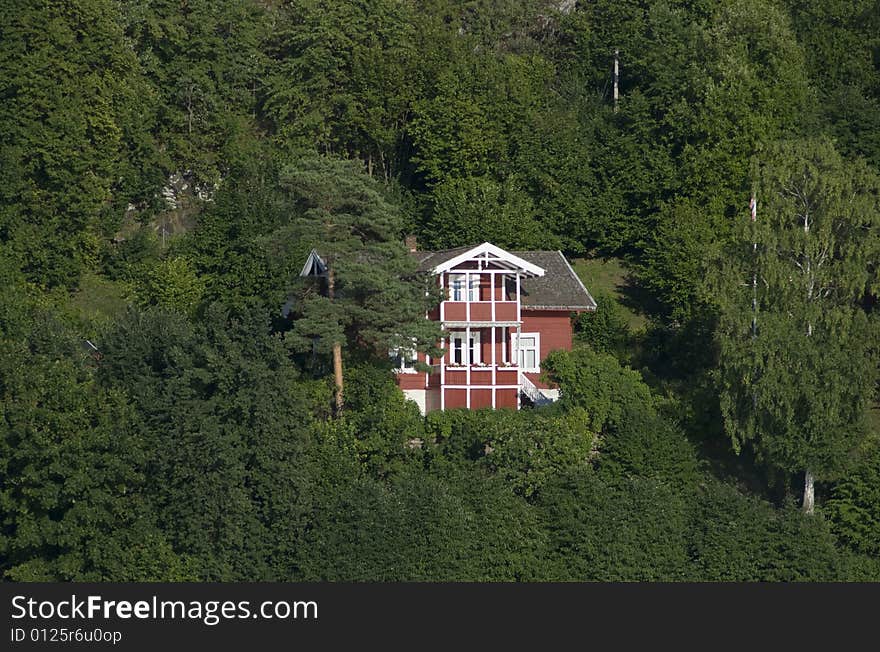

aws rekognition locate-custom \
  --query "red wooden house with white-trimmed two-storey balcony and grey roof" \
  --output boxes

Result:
[397,242,596,413]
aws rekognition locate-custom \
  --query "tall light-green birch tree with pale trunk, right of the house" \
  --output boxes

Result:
[713,140,880,513]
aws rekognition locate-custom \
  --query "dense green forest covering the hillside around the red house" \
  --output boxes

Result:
[0,0,880,581]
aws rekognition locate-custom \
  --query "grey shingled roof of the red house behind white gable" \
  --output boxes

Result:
[412,245,596,310]
